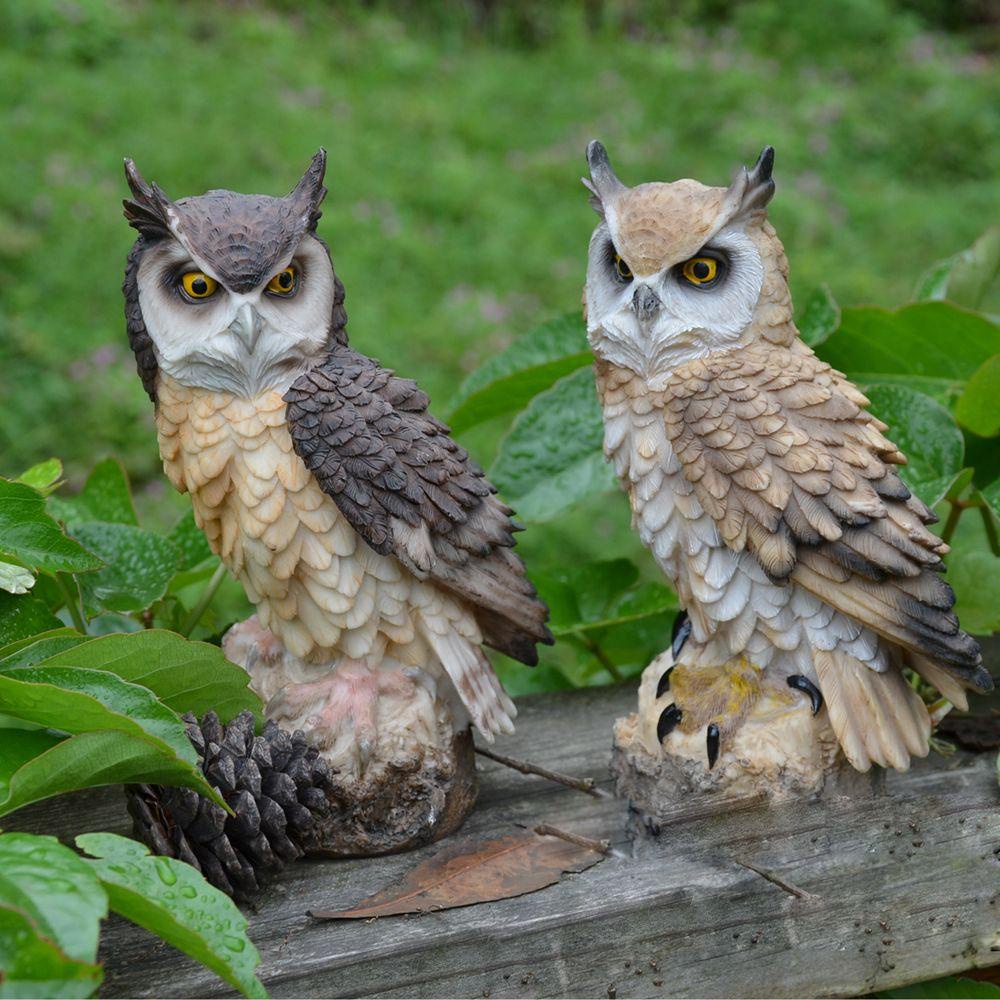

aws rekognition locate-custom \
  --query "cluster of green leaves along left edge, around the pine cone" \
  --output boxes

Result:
[0,459,266,997]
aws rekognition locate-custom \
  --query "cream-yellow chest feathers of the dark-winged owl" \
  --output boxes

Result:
[156,376,418,657]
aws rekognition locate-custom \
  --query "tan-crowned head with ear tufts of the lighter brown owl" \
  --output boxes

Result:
[583,142,791,388]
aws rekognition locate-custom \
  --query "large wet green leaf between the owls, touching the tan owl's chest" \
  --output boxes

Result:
[491,368,615,521]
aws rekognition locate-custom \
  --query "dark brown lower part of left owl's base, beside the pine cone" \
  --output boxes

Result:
[306,729,478,858]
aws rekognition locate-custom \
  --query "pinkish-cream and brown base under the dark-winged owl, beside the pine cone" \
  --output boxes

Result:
[223,615,477,858]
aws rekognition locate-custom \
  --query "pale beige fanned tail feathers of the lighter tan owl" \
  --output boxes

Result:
[813,650,931,771]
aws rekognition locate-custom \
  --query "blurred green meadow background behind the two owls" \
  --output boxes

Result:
[0,0,1000,508]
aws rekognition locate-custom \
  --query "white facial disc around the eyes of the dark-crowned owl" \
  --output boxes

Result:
[138,236,335,396]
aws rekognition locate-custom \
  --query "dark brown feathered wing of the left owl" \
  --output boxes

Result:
[285,345,553,664]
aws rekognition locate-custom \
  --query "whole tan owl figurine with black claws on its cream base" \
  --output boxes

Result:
[584,142,992,794]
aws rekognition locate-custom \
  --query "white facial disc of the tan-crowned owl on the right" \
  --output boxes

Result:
[587,223,764,389]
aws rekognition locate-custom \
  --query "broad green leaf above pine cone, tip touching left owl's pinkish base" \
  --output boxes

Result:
[38,629,261,722]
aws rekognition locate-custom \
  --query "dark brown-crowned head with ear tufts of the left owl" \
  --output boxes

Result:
[124,149,346,396]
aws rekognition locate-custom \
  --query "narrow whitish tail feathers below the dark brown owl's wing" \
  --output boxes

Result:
[421,618,517,743]
